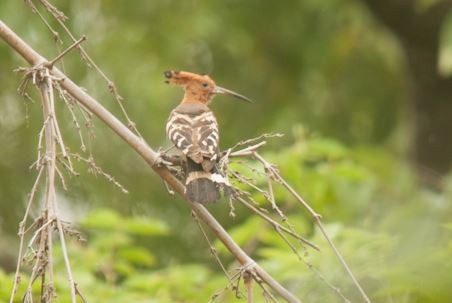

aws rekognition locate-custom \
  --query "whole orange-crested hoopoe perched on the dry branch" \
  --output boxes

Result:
[164,71,252,204]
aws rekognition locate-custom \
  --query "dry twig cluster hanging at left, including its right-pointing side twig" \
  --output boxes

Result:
[4,20,123,303]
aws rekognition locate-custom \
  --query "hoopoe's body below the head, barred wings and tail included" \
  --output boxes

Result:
[166,103,221,203]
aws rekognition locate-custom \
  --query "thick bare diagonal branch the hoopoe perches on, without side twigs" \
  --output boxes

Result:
[0,20,301,303]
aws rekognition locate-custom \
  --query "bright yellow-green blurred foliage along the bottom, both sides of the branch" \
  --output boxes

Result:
[0,132,452,303]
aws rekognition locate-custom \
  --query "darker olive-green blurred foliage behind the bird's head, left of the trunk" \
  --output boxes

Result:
[0,0,407,238]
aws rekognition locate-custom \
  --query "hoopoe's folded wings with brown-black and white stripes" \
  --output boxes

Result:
[166,111,219,163]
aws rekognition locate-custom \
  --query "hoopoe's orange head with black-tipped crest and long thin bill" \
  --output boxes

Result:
[164,70,252,104]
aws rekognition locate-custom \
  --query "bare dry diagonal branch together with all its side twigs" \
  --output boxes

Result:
[0,0,370,303]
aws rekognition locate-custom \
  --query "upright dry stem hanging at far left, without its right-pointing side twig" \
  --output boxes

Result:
[10,56,82,303]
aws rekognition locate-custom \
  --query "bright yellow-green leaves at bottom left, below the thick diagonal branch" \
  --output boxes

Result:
[0,209,251,303]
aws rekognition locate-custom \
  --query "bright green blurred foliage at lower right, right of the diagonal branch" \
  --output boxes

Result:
[218,132,452,302]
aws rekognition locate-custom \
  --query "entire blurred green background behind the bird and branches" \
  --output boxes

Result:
[0,0,452,303]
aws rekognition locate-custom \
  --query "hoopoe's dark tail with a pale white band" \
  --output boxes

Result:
[185,157,220,204]
